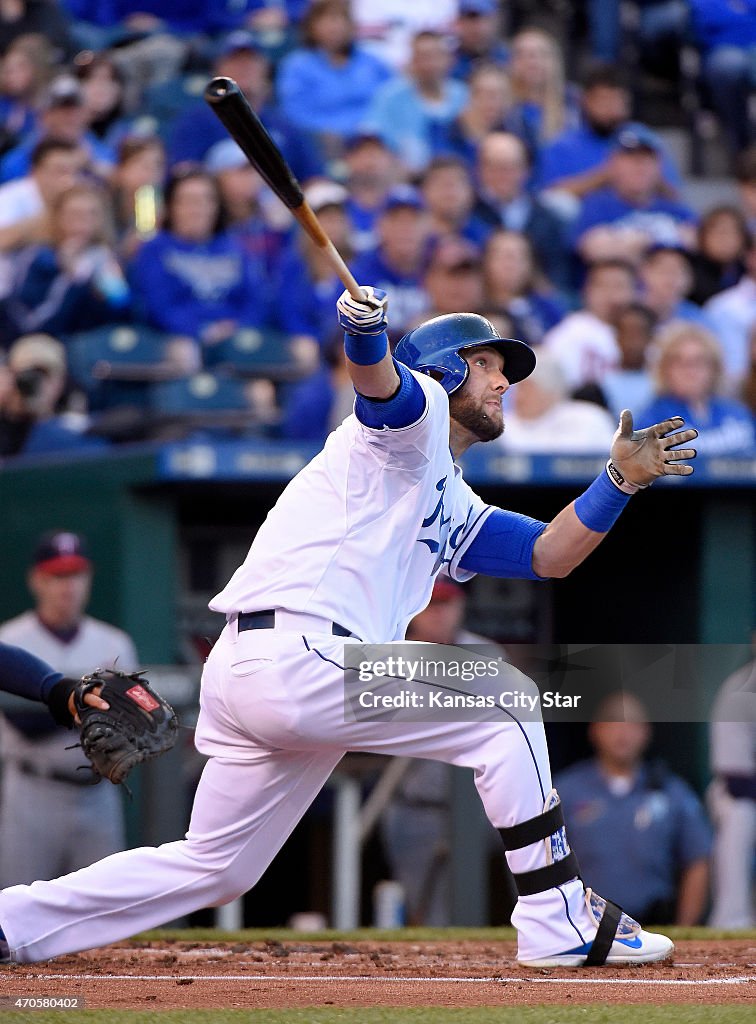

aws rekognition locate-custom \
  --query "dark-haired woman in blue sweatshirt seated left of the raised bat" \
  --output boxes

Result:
[131,168,267,349]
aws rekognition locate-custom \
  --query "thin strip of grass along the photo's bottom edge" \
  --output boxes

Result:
[2,1004,753,1024]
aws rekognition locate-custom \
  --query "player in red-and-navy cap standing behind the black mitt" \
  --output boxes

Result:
[0,530,138,885]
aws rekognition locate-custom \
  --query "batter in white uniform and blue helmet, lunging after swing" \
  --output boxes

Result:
[0,289,697,968]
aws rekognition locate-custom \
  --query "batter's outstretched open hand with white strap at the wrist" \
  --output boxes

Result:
[606,409,699,495]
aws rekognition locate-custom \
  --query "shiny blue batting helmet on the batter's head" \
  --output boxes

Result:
[393,313,536,394]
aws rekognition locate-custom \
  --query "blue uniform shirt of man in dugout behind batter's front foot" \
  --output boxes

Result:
[554,760,711,920]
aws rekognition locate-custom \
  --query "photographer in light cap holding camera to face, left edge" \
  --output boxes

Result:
[0,334,106,458]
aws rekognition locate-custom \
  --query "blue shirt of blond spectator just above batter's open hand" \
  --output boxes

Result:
[636,394,756,455]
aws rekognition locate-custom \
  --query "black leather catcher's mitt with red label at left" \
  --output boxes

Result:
[74,669,178,784]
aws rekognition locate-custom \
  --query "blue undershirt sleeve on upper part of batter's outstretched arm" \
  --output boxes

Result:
[452,509,546,580]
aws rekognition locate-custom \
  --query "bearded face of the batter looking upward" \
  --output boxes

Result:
[449,348,509,441]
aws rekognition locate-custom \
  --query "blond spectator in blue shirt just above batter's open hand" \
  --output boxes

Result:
[637,322,756,456]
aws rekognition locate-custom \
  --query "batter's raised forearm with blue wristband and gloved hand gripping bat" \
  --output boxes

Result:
[336,288,401,400]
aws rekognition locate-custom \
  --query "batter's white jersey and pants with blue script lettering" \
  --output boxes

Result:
[0,374,595,963]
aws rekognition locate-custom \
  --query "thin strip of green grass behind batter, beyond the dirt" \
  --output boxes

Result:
[135,926,756,942]
